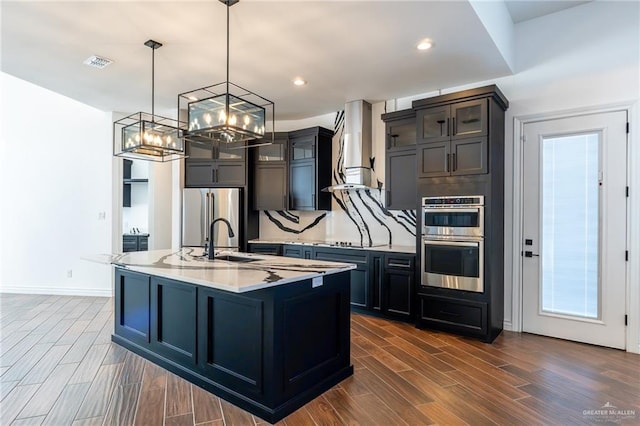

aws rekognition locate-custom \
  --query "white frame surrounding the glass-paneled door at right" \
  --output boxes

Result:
[505,102,640,353]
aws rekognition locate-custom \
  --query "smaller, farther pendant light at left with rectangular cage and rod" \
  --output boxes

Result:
[113,40,185,162]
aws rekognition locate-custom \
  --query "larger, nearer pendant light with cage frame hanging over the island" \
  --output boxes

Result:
[178,0,275,148]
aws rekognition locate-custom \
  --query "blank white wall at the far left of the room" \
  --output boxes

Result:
[0,73,113,296]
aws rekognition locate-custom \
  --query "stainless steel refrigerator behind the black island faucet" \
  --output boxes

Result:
[182,188,241,251]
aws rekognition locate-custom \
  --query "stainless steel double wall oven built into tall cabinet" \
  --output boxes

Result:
[421,195,484,293]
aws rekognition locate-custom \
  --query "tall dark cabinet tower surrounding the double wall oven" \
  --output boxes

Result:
[412,85,509,342]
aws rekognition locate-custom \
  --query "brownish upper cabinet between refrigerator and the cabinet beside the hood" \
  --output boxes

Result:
[251,133,289,210]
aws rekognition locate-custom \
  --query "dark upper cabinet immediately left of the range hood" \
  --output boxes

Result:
[289,127,333,210]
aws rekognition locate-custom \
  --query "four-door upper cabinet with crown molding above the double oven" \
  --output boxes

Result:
[413,86,507,178]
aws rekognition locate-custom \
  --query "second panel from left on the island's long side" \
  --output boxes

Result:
[151,277,198,366]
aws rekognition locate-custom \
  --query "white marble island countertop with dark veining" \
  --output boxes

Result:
[107,248,356,293]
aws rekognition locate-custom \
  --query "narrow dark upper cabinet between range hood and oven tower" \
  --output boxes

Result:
[382,109,417,210]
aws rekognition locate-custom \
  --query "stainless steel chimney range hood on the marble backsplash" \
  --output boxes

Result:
[323,100,378,192]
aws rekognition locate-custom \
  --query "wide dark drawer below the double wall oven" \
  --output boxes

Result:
[420,296,488,334]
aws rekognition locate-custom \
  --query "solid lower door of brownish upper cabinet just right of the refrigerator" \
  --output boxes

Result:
[253,163,288,210]
